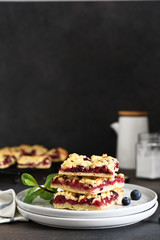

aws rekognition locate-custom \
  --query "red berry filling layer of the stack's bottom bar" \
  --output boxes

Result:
[53,191,118,207]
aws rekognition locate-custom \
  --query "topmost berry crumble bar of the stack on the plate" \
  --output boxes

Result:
[59,153,119,177]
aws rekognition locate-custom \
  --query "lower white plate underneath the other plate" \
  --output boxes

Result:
[18,202,158,229]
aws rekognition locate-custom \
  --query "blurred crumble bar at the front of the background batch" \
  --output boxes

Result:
[17,155,52,169]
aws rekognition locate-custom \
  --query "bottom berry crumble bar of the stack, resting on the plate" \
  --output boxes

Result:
[53,188,123,211]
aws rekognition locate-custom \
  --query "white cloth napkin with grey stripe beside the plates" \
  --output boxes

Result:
[0,189,28,223]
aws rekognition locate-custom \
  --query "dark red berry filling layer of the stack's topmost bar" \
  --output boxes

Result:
[60,165,113,174]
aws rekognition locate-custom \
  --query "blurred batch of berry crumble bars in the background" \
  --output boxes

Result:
[0,144,68,169]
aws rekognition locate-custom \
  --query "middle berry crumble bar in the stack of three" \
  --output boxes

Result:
[51,174,125,194]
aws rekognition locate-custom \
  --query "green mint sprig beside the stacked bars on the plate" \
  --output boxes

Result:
[21,173,57,204]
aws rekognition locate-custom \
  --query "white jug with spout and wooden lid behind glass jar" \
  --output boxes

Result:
[111,111,149,169]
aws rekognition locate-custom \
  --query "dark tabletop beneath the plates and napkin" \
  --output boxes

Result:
[0,170,160,240]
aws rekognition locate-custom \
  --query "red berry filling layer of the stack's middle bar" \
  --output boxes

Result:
[52,177,125,191]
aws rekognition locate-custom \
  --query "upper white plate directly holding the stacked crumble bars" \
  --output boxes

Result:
[16,184,157,219]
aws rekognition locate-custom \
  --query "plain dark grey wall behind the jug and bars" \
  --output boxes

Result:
[0,2,160,158]
